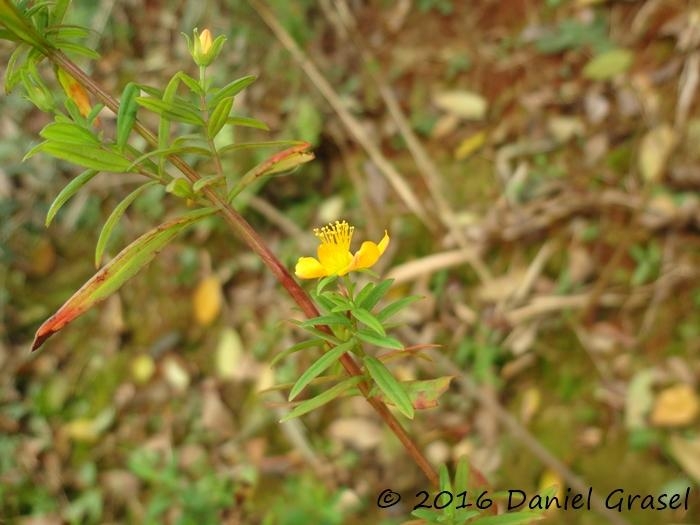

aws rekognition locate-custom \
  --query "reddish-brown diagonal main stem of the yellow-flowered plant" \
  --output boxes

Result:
[47,49,448,486]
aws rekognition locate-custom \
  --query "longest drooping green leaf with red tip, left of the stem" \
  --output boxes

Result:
[32,208,215,351]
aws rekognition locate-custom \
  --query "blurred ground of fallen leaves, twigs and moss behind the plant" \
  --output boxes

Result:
[0,0,700,525]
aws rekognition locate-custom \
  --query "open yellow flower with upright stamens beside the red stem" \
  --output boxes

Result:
[294,221,389,279]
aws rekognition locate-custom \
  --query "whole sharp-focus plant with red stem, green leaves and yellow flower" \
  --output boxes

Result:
[0,0,548,523]
